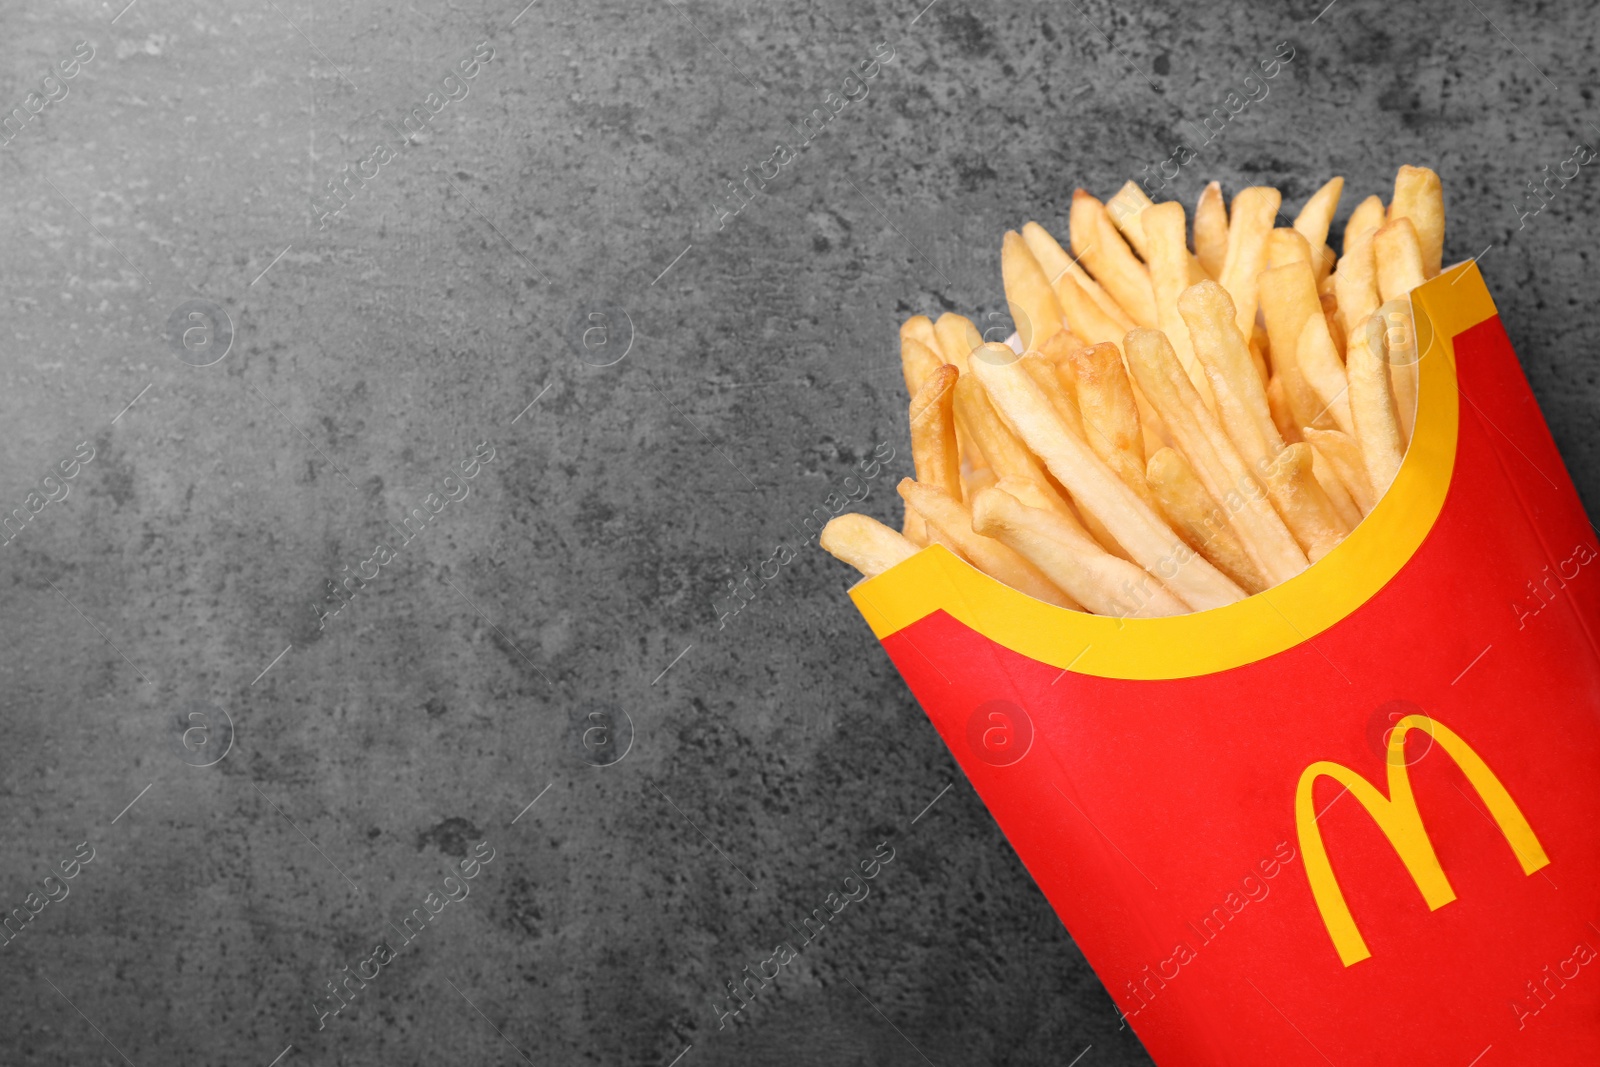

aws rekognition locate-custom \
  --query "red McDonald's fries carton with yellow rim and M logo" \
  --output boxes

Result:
[851,262,1600,1067]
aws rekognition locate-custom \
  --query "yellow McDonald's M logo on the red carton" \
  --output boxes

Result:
[1294,715,1550,966]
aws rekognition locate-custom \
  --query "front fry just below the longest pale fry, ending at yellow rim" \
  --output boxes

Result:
[973,488,1189,619]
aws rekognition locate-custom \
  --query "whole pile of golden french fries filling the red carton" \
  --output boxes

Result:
[821,166,1445,617]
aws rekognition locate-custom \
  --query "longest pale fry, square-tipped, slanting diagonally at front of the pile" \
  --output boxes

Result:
[973,346,1242,611]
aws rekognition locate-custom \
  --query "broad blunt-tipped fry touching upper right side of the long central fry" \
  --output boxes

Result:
[1178,282,1283,464]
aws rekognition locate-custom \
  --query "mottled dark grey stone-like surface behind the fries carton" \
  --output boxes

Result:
[0,0,1600,1067]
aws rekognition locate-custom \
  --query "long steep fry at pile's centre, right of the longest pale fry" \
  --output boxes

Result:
[1123,331,1310,584]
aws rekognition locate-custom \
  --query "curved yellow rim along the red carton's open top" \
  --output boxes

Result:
[850,261,1496,678]
